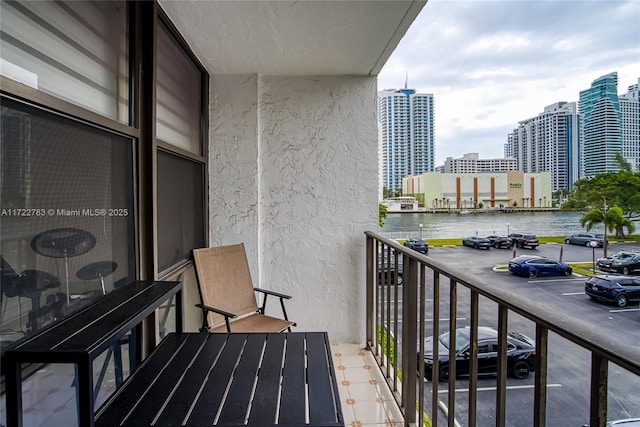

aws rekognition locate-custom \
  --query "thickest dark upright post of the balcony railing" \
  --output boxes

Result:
[402,256,418,425]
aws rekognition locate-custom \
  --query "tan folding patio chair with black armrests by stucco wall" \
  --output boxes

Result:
[193,243,295,333]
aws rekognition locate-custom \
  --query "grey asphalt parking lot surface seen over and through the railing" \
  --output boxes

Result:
[390,244,640,427]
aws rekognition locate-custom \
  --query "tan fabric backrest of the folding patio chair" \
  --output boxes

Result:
[193,243,258,327]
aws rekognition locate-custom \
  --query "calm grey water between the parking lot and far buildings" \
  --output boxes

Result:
[381,212,603,239]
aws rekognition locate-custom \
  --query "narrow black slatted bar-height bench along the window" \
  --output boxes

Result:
[2,281,182,426]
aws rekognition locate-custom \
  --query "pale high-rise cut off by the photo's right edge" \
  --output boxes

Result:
[619,78,640,170]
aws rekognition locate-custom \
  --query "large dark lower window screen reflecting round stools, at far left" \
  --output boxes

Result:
[0,97,136,348]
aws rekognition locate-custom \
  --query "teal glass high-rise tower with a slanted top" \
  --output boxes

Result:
[578,72,622,177]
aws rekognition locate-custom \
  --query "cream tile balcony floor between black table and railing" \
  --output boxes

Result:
[331,344,404,427]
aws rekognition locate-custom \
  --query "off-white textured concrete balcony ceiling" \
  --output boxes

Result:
[159,0,426,75]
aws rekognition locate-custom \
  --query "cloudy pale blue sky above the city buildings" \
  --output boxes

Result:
[378,0,640,166]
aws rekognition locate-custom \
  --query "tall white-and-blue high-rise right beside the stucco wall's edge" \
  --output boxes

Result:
[378,87,435,191]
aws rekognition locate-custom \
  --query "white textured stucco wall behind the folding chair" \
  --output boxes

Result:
[210,76,378,342]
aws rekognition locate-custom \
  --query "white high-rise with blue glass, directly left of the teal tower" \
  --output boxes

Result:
[504,102,580,191]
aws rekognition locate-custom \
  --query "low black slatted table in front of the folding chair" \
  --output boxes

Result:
[96,332,344,427]
